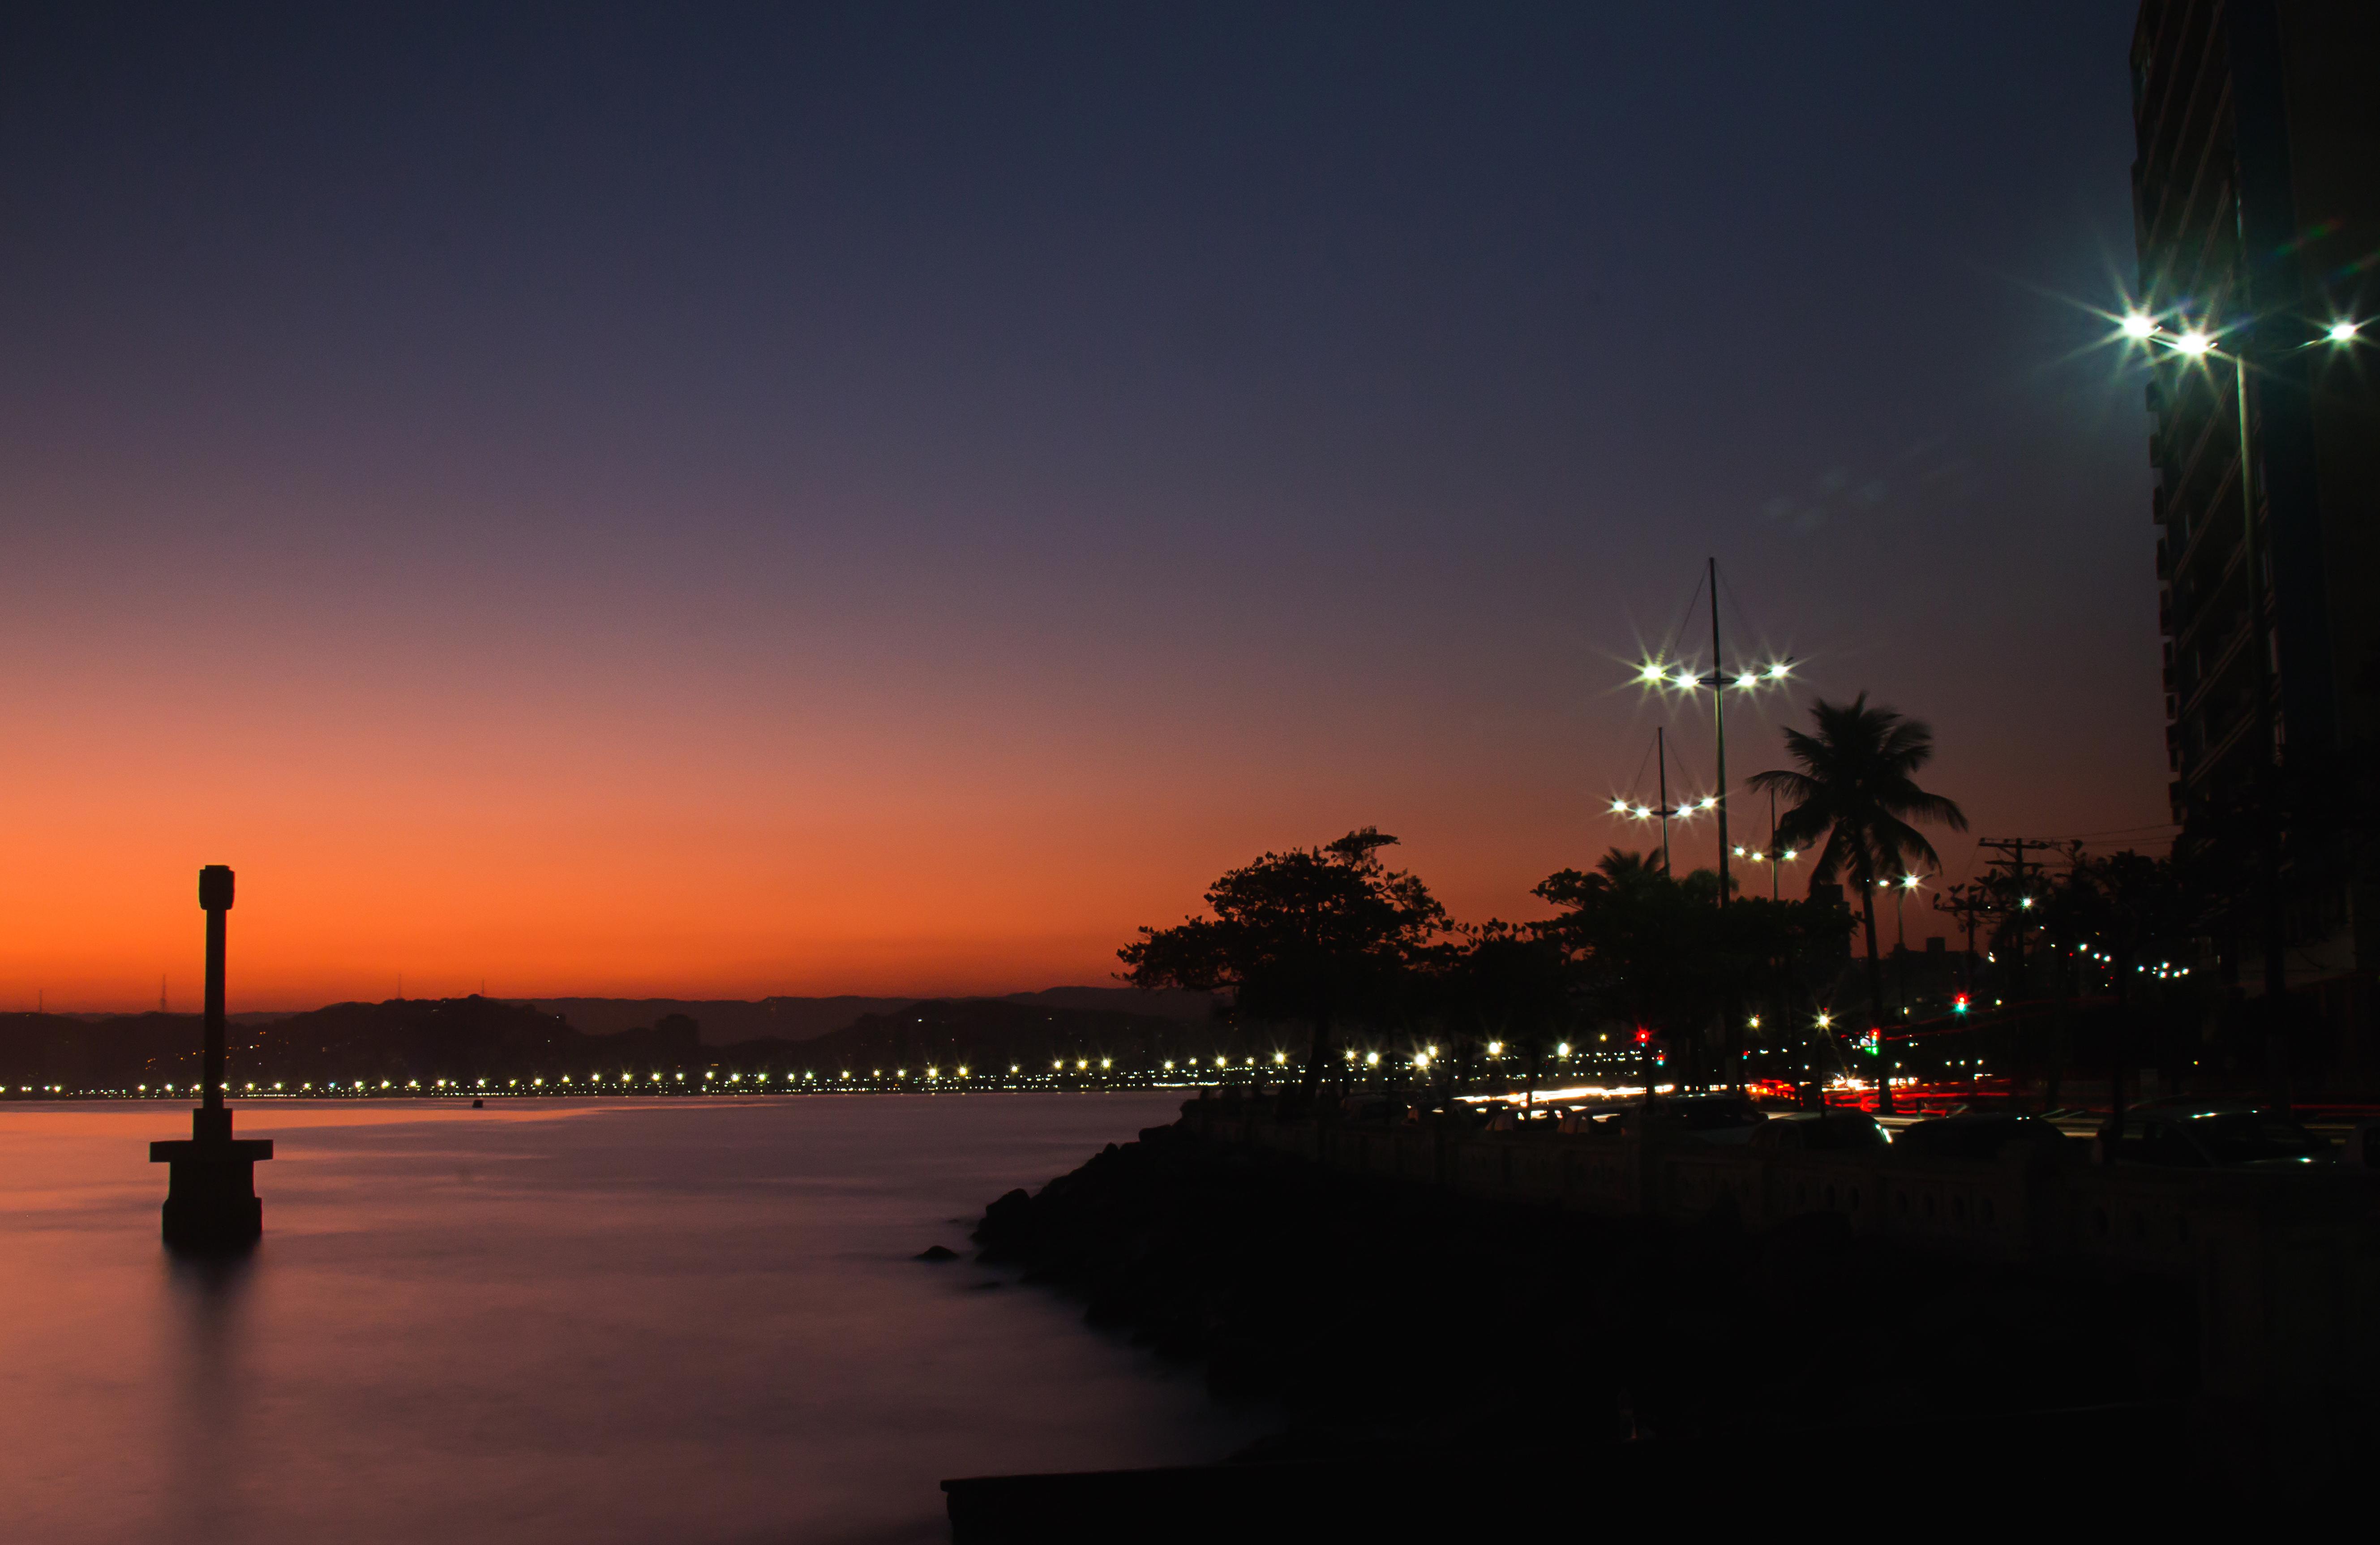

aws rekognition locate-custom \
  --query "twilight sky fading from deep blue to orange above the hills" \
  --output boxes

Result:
[0,0,2166,1009]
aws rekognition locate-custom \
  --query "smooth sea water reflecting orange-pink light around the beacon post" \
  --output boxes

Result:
[0,1093,1259,1545]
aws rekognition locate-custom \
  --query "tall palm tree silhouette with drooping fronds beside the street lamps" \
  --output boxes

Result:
[1752,693,1966,1112]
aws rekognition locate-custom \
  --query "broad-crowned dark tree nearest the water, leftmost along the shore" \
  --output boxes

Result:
[1116,826,1447,1105]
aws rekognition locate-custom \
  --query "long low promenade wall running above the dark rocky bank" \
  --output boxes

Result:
[1183,1100,2380,1412]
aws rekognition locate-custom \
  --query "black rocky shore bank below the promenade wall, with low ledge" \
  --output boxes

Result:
[945,1109,2361,1545]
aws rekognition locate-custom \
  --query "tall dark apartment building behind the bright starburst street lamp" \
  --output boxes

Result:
[2132,0,2380,1038]
